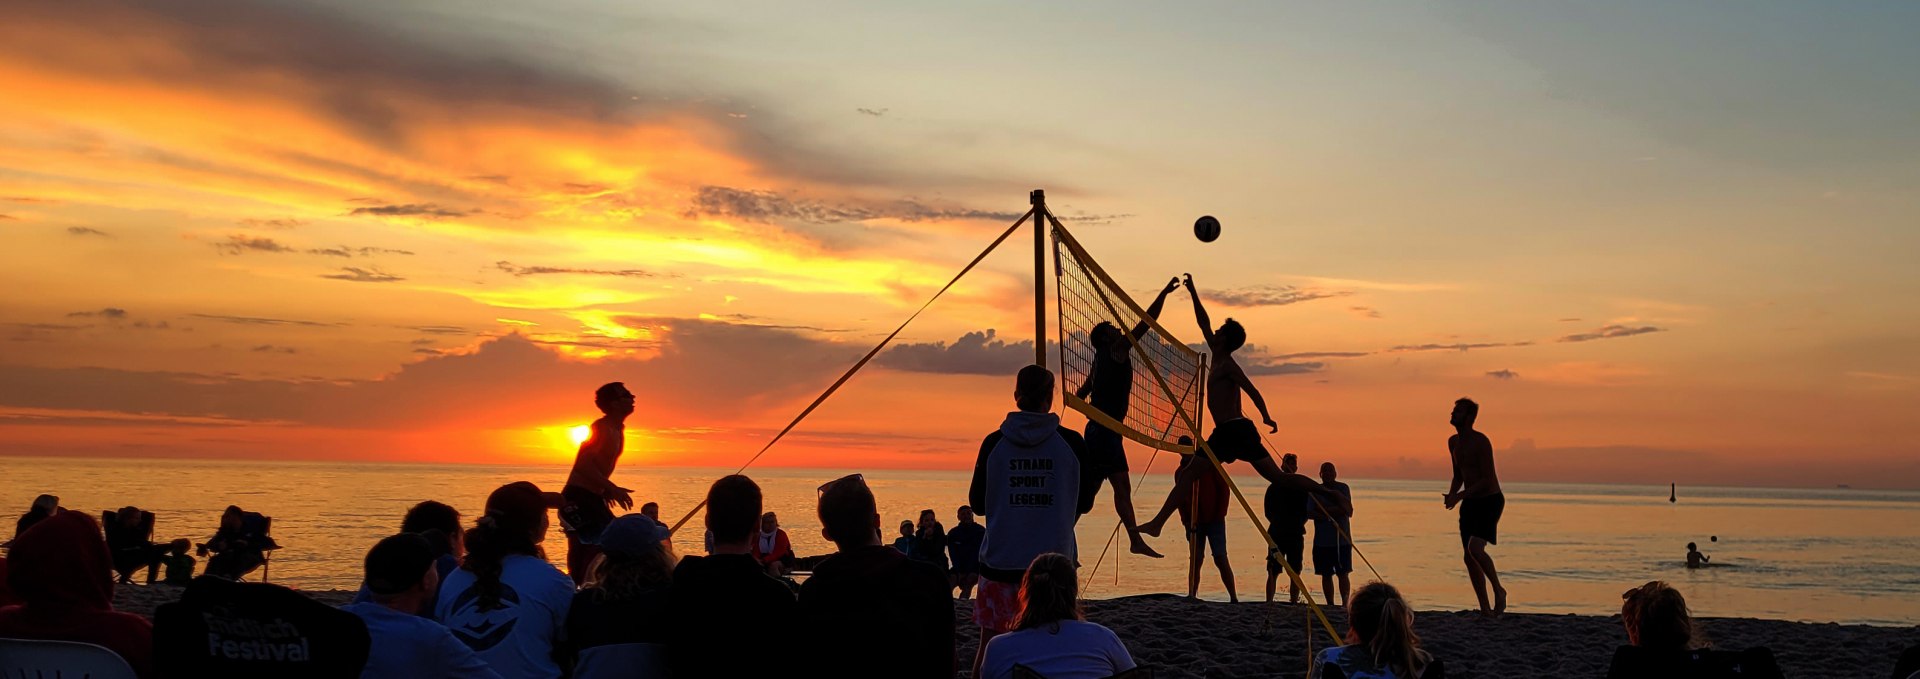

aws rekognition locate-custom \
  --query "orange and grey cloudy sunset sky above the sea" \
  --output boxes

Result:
[0,0,1920,487]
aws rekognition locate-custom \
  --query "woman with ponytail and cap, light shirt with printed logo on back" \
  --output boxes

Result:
[434,481,574,679]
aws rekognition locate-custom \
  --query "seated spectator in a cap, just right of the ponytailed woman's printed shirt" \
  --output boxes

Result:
[566,514,678,679]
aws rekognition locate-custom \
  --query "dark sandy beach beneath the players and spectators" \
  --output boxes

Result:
[115,585,1920,679]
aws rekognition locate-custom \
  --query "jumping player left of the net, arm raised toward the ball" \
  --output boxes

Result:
[1073,278,1181,558]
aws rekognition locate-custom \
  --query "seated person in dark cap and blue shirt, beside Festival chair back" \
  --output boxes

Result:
[342,533,499,679]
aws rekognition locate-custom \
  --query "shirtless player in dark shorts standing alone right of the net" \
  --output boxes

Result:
[1444,399,1507,616]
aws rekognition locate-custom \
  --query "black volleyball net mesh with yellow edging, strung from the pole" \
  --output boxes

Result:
[1052,222,1206,453]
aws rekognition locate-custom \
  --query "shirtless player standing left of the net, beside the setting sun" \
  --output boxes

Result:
[561,382,634,585]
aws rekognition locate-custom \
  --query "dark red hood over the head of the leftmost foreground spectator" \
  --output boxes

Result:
[6,512,113,610]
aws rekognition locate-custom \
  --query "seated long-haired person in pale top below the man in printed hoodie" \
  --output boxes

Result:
[981,554,1135,679]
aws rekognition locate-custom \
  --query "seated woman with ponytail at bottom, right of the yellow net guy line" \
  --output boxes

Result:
[1311,583,1446,679]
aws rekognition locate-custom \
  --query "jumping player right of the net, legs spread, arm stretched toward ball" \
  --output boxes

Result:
[1140,274,1354,537]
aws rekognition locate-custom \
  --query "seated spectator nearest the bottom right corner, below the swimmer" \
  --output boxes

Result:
[1607,581,1780,679]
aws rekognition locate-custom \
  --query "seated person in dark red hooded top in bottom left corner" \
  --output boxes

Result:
[0,512,154,677]
